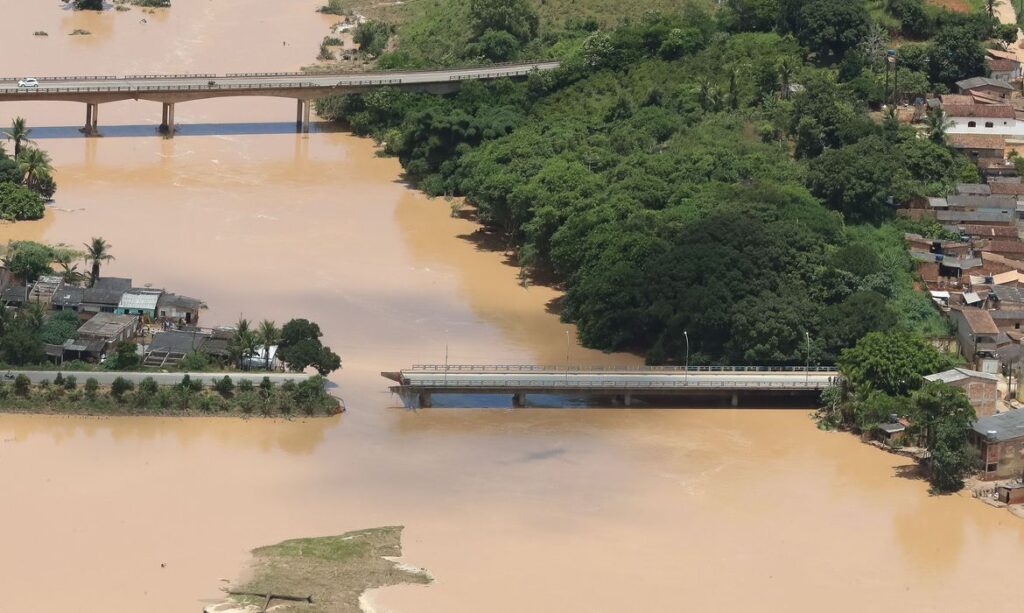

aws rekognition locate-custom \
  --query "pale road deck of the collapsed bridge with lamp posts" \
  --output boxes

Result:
[401,370,838,390]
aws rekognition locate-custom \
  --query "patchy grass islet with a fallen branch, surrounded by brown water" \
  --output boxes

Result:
[206,526,431,613]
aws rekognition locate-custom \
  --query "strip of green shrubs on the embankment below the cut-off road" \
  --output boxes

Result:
[0,375,342,418]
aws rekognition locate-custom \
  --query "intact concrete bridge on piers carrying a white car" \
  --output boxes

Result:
[0,61,559,135]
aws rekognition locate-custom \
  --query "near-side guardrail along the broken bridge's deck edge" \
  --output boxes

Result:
[394,379,827,390]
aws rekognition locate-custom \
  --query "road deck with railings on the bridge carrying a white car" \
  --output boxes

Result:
[0,61,559,98]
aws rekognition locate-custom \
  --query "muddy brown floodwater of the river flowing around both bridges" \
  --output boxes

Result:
[0,0,1024,613]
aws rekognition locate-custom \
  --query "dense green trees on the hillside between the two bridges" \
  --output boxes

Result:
[317,0,997,365]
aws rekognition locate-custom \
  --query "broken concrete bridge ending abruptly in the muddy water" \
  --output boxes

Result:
[381,364,839,407]
